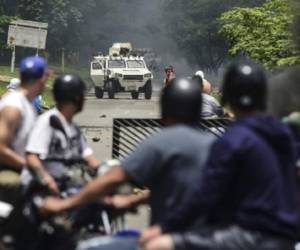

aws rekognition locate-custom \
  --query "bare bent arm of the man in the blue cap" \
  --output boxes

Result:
[0,107,26,170]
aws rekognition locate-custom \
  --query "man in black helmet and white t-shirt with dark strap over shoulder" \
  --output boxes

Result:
[26,75,100,193]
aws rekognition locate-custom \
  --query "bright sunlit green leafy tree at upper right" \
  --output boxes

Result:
[220,0,299,68]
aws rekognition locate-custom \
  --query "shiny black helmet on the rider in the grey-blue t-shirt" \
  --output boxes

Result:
[160,78,202,123]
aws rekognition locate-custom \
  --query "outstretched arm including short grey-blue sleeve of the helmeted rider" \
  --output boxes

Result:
[43,136,161,212]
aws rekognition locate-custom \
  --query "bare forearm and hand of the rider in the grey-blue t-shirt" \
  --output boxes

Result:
[42,166,128,213]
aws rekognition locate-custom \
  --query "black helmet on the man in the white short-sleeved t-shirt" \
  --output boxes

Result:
[53,75,86,110]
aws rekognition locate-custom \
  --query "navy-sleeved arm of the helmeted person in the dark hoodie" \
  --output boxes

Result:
[161,138,235,232]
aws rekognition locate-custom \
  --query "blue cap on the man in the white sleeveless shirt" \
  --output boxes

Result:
[20,56,47,82]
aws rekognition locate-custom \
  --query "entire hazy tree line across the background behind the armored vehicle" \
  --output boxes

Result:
[0,0,300,71]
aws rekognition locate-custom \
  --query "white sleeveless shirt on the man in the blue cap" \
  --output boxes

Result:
[0,91,37,156]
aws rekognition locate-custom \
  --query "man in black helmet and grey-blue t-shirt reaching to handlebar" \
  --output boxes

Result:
[44,79,214,227]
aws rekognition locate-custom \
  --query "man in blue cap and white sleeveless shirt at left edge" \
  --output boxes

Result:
[0,57,49,203]
